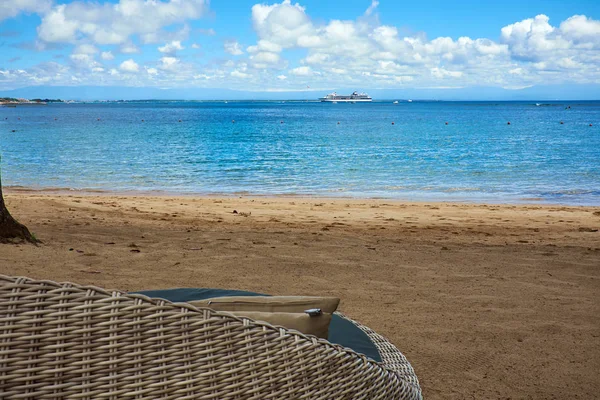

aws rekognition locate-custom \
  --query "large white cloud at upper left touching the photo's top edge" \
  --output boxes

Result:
[37,0,208,45]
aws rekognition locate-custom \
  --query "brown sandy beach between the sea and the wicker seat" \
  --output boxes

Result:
[0,191,600,399]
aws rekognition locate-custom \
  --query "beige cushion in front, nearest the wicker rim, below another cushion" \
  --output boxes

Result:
[221,311,331,339]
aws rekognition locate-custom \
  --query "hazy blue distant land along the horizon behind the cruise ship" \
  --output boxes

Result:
[0,84,600,101]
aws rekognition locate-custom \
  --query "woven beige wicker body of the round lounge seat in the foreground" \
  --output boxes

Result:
[0,275,421,400]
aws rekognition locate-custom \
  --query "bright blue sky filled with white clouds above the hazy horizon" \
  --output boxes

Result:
[0,0,600,95]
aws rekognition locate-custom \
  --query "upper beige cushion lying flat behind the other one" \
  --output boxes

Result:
[190,296,340,314]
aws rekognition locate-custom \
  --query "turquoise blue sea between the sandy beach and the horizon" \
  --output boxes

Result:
[0,101,600,205]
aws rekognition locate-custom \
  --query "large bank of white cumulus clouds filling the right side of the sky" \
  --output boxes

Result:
[247,0,600,87]
